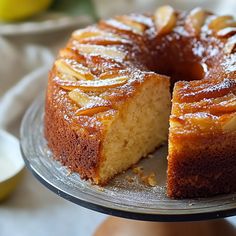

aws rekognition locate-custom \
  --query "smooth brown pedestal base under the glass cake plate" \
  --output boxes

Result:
[94,217,236,236]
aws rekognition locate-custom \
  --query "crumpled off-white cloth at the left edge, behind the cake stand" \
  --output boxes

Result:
[0,38,54,133]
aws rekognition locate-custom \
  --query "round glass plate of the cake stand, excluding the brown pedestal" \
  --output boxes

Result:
[21,96,236,234]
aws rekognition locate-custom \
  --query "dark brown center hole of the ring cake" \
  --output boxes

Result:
[145,41,208,87]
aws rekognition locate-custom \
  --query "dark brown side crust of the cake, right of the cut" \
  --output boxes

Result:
[167,132,236,198]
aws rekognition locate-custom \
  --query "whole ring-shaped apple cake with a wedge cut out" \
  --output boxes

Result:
[45,6,236,198]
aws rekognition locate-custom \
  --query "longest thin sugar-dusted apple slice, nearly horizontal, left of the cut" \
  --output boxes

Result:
[55,76,128,91]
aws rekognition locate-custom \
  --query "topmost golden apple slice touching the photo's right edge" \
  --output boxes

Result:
[208,15,236,34]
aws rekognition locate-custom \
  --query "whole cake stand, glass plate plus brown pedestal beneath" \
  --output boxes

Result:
[21,96,236,236]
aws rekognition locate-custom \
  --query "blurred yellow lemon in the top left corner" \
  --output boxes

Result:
[0,0,52,21]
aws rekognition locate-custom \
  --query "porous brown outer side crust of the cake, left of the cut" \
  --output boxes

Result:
[45,75,100,181]
